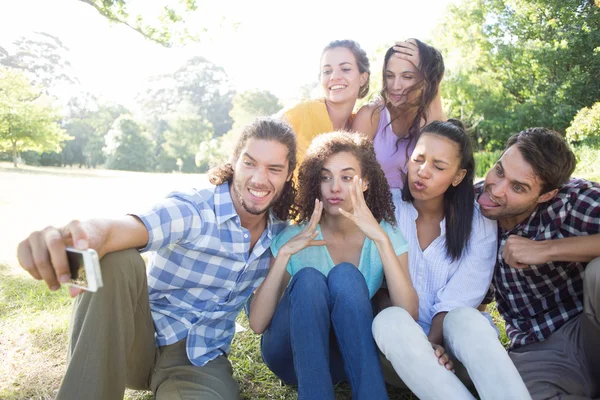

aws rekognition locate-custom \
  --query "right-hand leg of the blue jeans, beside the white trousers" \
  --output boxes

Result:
[327,263,388,400]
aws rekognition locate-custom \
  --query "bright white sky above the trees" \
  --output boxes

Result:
[0,0,455,106]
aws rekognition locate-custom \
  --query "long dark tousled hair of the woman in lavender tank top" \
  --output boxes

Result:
[379,39,445,164]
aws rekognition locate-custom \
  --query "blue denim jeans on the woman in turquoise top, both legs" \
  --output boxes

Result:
[261,263,388,400]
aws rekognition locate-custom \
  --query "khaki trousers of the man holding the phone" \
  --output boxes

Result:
[57,250,239,400]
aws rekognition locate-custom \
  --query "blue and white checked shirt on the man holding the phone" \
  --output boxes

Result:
[134,183,285,366]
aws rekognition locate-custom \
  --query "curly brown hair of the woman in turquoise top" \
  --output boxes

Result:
[296,131,396,225]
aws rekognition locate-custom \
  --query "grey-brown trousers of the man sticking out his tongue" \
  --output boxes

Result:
[510,258,600,400]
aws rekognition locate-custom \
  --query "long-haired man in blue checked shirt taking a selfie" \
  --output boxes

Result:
[18,118,296,400]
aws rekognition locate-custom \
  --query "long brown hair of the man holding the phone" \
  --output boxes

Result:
[208,117,298,221]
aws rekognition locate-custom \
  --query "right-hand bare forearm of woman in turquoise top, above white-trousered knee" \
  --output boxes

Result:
[376,239,419,320]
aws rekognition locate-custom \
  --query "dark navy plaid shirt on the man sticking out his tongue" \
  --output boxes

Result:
[478,179,600,349]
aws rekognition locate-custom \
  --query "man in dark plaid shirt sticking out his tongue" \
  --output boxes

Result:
[478,128,600,399]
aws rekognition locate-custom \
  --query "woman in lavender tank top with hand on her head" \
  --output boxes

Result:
[352,39,446,200]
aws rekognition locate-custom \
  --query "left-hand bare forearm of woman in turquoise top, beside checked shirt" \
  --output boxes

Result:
[249,254,290,334]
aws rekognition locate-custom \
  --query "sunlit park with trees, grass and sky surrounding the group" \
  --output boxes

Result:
[0,0,600,399]
